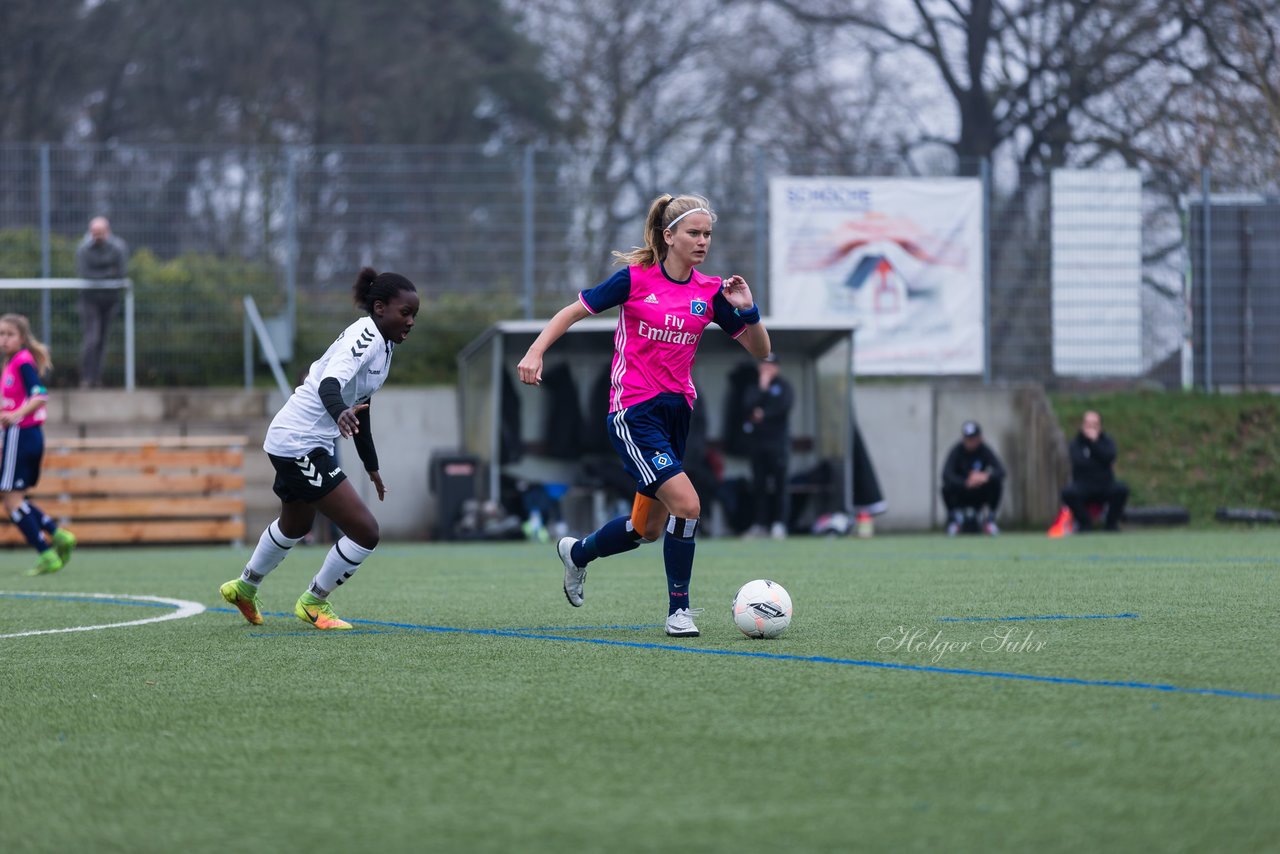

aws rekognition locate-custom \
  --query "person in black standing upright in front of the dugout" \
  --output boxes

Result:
[742,352,795,539]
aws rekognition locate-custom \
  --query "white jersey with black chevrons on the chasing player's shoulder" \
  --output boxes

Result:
[262,316,396,457]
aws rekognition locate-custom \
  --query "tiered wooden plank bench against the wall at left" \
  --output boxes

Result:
[0,435,248,545]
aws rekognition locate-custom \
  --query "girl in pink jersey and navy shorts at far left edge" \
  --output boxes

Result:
[0,314,76,575]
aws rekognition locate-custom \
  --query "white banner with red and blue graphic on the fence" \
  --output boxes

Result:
[768,178,983,375]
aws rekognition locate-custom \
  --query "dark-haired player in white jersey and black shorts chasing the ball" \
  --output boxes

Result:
[220,266,419,629]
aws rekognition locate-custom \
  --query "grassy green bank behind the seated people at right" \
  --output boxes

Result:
[1051,392,1280,528]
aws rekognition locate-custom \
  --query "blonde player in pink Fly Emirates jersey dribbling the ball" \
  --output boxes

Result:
[516,195,769,638]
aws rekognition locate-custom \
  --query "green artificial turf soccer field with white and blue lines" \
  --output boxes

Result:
[0,531,1280,854]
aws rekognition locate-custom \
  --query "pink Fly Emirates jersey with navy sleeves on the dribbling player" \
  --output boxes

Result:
[579,264,746,412]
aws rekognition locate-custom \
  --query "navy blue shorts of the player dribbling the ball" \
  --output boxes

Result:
[609,393,694,498]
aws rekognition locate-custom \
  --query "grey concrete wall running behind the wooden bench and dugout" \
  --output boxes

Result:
[46,382,1066,540]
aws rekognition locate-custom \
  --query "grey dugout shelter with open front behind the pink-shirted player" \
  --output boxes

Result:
[458,315,856,529]
